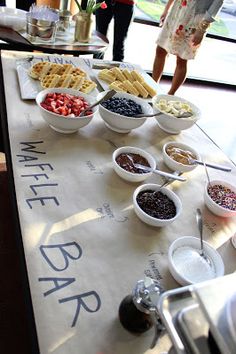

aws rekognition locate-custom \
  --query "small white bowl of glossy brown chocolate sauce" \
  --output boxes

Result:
[112,146,156,182]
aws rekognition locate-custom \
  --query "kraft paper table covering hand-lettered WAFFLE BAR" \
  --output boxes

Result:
[2,51,236,354]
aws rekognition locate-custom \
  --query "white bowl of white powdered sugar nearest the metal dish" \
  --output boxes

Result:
[168,236,224,285]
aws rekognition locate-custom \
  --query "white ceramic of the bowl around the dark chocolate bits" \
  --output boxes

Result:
[133,183,182,227]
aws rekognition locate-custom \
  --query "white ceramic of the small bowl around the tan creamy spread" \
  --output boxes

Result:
[162,141,201,172]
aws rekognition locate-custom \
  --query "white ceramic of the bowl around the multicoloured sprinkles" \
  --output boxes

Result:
[204,180,236,218]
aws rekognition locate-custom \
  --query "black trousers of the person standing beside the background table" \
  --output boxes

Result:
[94,0,135,61]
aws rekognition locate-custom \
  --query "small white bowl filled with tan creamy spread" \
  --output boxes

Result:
[162,141,201,172]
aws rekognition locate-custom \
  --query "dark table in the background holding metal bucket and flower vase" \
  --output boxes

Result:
[0,27,109,56]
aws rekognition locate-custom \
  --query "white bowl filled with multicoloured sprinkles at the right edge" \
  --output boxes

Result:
[204,180,236,217]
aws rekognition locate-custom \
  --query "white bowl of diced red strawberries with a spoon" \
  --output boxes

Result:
[36,88,98,134]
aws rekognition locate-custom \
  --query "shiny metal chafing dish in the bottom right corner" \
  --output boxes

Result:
[158,273,236,354]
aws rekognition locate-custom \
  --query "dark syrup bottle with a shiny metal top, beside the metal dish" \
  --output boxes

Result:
[119,277,164,348]
